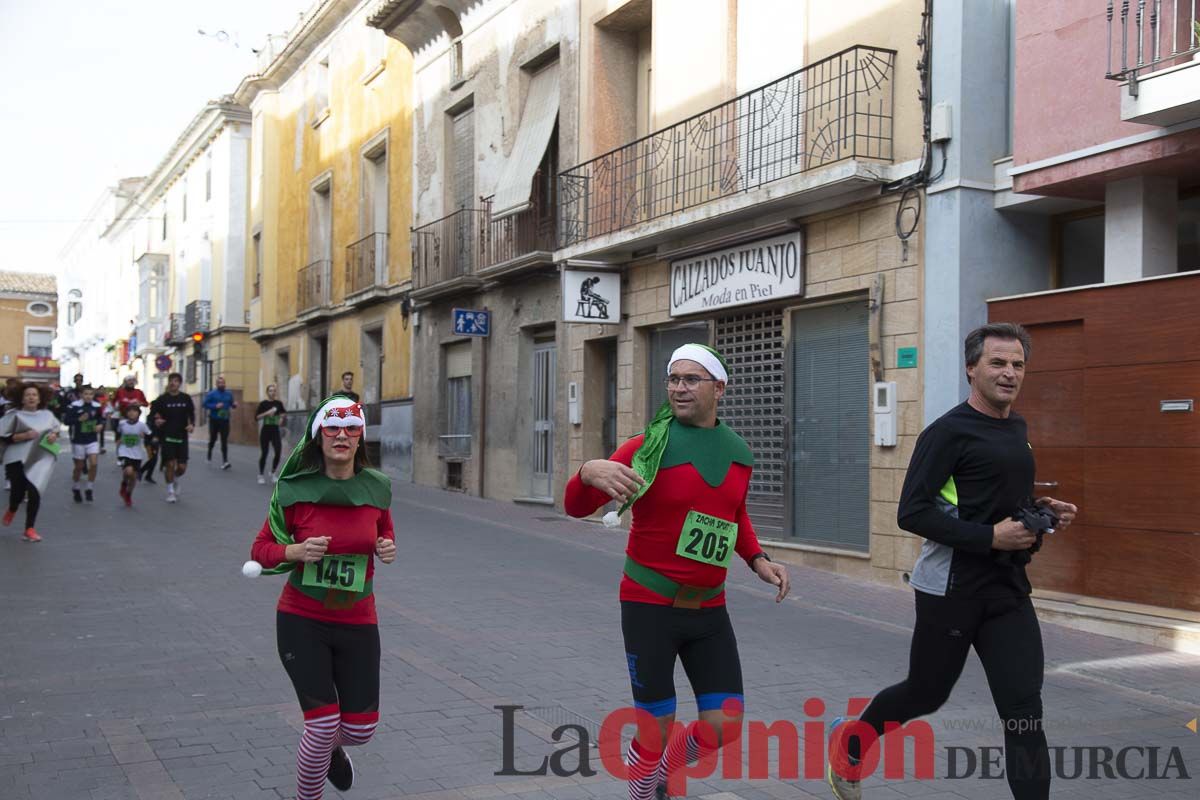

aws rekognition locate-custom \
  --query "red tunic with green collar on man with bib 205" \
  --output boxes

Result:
[564,405,762,608]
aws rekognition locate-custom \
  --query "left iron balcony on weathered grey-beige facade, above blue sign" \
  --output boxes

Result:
[412,209,490,300]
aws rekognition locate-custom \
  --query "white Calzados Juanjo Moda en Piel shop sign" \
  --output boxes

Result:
[671,230,804,317]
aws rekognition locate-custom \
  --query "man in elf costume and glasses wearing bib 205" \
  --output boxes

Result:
[564,344,790,800]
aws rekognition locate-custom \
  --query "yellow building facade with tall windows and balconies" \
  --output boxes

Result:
[235,0,413,477]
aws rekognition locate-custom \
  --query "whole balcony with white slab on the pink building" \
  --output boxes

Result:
[1104,0,1200,127]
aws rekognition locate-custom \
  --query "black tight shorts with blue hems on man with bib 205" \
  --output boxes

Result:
[620,601,743,717]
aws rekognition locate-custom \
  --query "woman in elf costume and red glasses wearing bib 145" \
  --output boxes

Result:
[242,395,396,800]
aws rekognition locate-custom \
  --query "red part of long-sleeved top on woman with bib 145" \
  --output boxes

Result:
[250,503,396,625]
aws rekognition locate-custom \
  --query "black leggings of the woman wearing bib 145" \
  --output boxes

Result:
[275,612,379,714]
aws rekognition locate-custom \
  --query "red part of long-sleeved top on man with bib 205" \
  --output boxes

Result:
[563,434,762,608]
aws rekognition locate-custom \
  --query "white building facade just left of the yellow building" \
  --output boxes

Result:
[104,97,258,441]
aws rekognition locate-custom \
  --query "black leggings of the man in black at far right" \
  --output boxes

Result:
[847,591,1050,800]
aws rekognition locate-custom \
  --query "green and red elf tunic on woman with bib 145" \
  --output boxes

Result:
[250,396,396,625]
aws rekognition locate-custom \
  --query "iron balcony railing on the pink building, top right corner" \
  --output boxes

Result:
[1104,0,1200,85]
